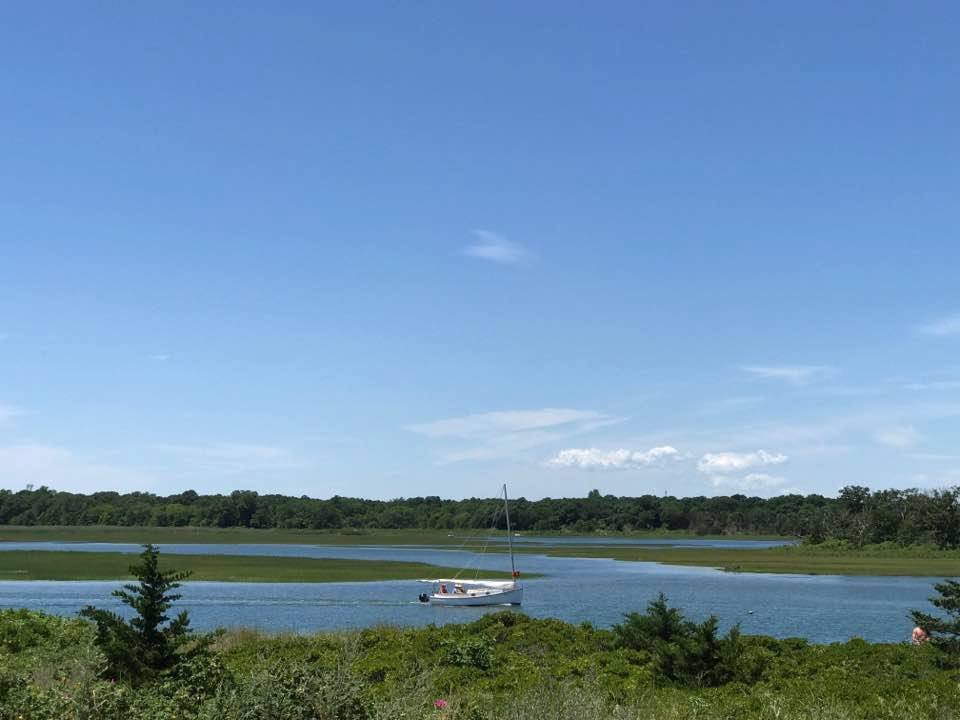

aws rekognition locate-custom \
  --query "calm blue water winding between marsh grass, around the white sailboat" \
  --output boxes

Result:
[0,539,934,642]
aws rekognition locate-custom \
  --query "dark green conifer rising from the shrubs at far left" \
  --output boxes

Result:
[80,545,191,682]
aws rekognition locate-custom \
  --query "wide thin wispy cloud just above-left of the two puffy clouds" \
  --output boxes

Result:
[406,408,624,462]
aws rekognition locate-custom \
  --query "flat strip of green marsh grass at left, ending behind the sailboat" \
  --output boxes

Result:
[0,550,509,582]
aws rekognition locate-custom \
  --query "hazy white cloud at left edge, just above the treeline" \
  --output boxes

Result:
[0,445,155,493]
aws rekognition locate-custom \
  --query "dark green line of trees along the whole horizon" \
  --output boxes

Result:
[0,486,960,548]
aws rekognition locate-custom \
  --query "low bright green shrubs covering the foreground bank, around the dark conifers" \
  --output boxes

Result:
[0,610,960,720]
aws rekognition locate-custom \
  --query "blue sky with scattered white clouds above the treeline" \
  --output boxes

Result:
[0,2,960,498]
